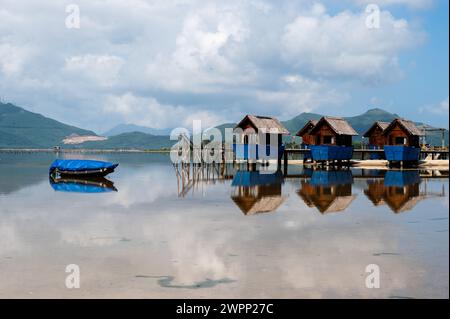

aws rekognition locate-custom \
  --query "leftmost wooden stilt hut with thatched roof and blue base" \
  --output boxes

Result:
[233,115,289,160]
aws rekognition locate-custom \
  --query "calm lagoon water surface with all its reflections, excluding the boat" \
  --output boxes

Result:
[0,152,449,298]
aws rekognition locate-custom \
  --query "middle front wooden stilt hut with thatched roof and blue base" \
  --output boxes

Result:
[309,116,358,161]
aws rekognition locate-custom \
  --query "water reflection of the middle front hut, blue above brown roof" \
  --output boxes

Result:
[298,171,356,214]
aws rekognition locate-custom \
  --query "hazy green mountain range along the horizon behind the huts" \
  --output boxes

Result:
[0,102,448,150]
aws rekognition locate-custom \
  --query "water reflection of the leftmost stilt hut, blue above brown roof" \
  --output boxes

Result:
[231,171,285,215]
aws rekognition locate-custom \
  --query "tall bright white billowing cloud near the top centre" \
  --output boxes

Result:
[147,5,255,92]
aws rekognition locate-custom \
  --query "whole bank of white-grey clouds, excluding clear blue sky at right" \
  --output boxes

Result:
[0,0,430,131]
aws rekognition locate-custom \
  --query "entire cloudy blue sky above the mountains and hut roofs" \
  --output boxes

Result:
[0,0,449,133]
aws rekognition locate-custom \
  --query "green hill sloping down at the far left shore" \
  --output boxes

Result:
[0,102,95,148]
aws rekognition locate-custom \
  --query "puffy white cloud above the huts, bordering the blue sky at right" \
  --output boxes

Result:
[282,5,423,83]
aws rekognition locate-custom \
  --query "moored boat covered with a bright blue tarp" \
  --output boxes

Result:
[49,160,119,177]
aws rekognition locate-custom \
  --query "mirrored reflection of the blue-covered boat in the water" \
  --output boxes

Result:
[50,177,117,194]
